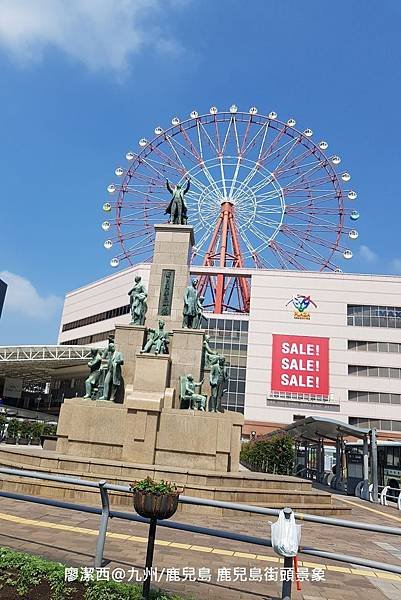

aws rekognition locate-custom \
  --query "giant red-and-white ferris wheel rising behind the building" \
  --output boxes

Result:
[102,105,359,312]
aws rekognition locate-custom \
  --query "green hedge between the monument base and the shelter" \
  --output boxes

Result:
[240,434,294,475]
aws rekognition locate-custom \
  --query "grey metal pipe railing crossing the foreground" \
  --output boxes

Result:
[0,467,401,600]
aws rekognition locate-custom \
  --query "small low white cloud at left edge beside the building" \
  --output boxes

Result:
[0,271,63,320]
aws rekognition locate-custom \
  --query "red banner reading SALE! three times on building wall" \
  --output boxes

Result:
[271,334,329,396]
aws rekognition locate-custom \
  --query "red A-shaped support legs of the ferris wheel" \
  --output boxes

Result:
[198,201,250,314]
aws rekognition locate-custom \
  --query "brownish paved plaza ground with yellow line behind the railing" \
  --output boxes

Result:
[0,497,401,600]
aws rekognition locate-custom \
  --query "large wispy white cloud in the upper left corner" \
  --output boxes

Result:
[0,0,189,71]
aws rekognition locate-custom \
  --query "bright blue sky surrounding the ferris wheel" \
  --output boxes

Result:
[0,0,401,345]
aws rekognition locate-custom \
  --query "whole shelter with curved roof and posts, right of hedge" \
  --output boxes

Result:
[268,417,378,502]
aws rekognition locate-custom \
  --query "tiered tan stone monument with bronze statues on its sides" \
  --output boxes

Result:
[57,221,244,473]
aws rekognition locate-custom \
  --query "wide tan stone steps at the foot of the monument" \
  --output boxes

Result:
[0,449,349,517]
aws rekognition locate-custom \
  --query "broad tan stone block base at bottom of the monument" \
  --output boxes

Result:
[56,392,244,473]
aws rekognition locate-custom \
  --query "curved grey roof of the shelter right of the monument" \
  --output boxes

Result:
[276,417,369,443]
